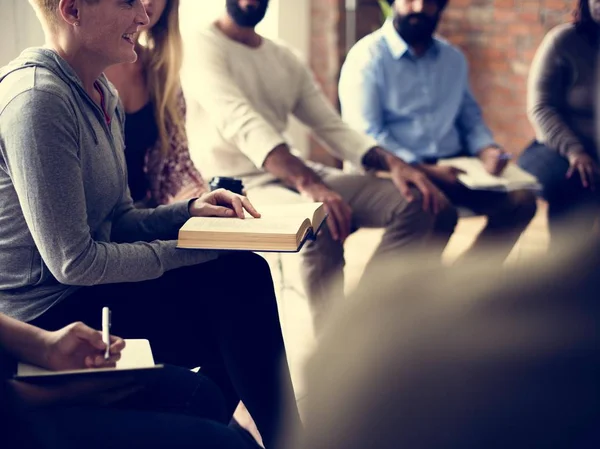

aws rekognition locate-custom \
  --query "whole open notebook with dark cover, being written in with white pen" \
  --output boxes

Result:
[15,340,163,381]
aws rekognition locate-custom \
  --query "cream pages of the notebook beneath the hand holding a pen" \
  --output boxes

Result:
[17,340,154,377]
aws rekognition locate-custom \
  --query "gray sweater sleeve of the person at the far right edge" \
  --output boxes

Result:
[527,30,584,156]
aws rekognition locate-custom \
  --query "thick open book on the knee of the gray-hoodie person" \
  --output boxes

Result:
[177,203,327,252]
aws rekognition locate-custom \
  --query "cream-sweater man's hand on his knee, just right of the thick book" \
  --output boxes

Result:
[300,183,352,243]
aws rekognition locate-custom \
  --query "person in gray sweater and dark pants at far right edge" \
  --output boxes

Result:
[518,0,600,246]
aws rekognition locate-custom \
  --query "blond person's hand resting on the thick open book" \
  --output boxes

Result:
[190,189,260,218]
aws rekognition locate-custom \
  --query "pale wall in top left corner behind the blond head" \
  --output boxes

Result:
[0,0,44,67]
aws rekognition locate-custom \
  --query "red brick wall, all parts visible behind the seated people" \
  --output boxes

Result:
[311,0,575,163]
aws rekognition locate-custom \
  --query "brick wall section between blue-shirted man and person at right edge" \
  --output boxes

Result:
[440,0,576,153]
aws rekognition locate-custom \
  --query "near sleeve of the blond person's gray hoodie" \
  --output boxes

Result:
[0,89,218,285]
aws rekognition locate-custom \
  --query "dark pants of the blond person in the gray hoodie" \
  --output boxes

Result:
[32,252,299,448]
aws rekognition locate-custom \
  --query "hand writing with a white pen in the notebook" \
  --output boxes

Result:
[39,323,125,371]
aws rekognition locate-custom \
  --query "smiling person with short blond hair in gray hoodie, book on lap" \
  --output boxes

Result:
[0,0,295,447]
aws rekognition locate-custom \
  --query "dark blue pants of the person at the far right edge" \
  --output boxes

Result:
[518,142,600,240]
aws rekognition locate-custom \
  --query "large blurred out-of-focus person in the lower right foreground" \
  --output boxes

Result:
[297,236,600,449]
